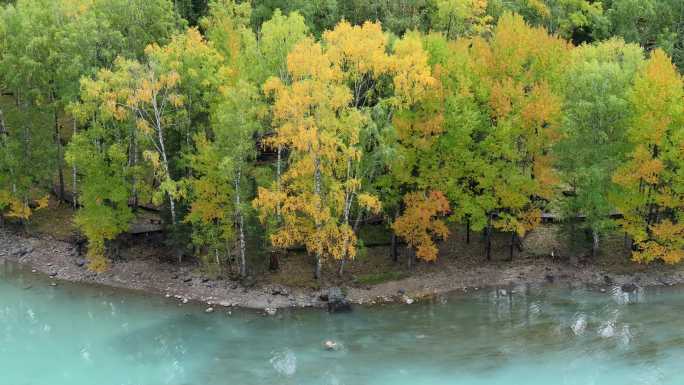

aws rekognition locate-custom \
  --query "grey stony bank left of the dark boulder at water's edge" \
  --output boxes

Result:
[0,230,321,309]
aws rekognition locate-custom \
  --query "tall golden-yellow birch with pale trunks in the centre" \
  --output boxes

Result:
[253,22,390,277]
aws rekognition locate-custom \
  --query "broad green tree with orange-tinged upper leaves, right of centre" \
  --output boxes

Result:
[436,14,568,257]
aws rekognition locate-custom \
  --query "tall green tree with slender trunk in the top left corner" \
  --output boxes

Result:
[0,0,115,202]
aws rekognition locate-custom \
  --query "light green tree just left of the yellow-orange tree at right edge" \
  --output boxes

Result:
[555,40,643,255]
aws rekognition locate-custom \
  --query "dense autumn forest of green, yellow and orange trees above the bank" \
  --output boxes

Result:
[0,0,684,277]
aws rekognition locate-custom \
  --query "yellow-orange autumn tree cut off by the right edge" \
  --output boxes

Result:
[613,50,684,263]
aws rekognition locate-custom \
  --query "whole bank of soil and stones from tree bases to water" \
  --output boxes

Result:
[0,198,684,309]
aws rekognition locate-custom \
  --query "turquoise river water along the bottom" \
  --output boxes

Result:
[0,264,684,385]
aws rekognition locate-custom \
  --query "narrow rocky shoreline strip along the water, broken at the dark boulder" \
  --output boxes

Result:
[0,230,684,314]
